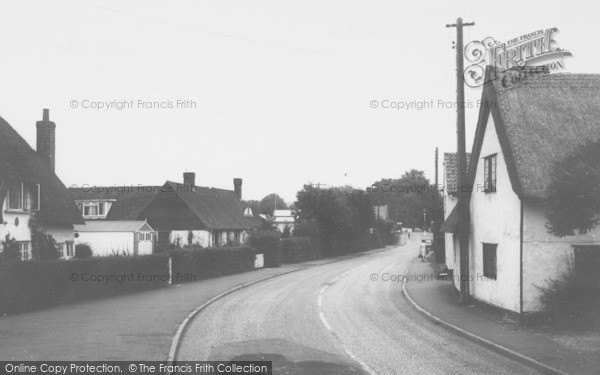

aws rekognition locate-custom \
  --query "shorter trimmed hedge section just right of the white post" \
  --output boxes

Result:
[169,246,256,284]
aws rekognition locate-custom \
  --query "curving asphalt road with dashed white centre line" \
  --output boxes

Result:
[177,239,538,374]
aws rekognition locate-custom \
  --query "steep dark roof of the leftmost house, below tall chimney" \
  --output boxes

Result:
[0,117,84,225]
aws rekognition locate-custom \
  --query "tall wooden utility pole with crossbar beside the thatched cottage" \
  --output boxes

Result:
[446,17,475,305]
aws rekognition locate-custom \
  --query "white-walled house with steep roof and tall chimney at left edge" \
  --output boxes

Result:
[0,109,83,260]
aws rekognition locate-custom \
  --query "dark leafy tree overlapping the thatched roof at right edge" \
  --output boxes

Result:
[546,141,600,237]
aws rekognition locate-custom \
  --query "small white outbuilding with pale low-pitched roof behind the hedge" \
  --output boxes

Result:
[75,220,155,256]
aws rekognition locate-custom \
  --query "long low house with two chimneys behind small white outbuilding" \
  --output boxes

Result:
[73,172,261,253]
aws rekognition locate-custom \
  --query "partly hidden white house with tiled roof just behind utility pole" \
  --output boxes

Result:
[440,152,471,270]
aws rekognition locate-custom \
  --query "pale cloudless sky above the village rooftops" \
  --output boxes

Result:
[0,0,600,202]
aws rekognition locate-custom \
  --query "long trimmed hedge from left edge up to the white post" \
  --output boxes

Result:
[0,255,168,314]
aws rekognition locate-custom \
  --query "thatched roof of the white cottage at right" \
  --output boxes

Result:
[470,67,600,198]
